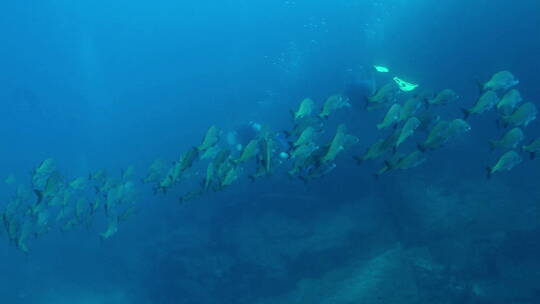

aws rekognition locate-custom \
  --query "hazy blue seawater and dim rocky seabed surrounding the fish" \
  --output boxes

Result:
[0,0,540,304]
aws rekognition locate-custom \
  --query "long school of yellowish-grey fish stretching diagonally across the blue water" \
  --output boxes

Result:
[0,71,540,252]
